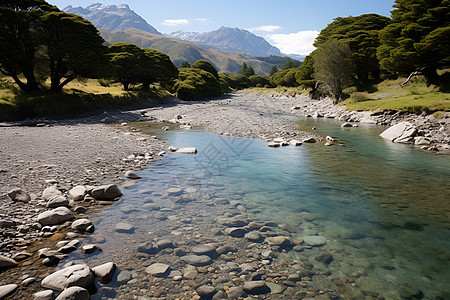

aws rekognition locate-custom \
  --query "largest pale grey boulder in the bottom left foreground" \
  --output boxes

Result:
[41,265,94,291]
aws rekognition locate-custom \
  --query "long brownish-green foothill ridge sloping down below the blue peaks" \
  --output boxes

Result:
[99,28,273,74]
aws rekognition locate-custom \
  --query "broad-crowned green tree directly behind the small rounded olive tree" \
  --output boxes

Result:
[314,14,390,89]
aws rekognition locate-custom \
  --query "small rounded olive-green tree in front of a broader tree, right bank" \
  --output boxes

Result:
[314,39,353,104]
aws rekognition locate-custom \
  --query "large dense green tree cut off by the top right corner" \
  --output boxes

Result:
[377,0,450,84]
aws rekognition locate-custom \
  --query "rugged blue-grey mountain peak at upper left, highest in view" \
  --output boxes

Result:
[63,3,161,34]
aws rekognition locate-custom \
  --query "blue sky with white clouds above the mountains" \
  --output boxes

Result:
[47,0,394,55]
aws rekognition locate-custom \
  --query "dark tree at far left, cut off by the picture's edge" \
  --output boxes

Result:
[0,0,58,91]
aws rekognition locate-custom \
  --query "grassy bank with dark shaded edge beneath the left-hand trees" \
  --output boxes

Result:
[0,78,168,121]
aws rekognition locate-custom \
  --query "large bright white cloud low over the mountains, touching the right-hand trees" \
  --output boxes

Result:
[267,30,319,55]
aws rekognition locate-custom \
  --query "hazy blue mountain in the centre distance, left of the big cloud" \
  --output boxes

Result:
[170,27,281,56]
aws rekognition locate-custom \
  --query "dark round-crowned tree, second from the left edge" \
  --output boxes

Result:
[40,12,106,93]
